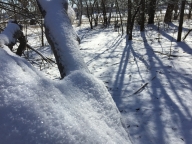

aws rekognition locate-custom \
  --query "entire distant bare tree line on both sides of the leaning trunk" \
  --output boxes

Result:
[0,0,192,41]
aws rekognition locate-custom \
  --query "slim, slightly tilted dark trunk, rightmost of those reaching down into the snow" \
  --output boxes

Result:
[177,0,186,42]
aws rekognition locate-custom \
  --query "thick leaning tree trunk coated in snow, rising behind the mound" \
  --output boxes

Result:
[36,0,89,78]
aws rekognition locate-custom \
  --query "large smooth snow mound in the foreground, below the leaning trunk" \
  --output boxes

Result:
[0,48,130,144]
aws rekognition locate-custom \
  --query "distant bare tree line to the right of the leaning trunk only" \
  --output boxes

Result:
[70,0,188,41]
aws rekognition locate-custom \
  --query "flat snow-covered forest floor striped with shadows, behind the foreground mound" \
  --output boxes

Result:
[25,21,192,144]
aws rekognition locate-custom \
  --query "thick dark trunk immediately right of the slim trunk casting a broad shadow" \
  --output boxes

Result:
[148,0,156,24]
